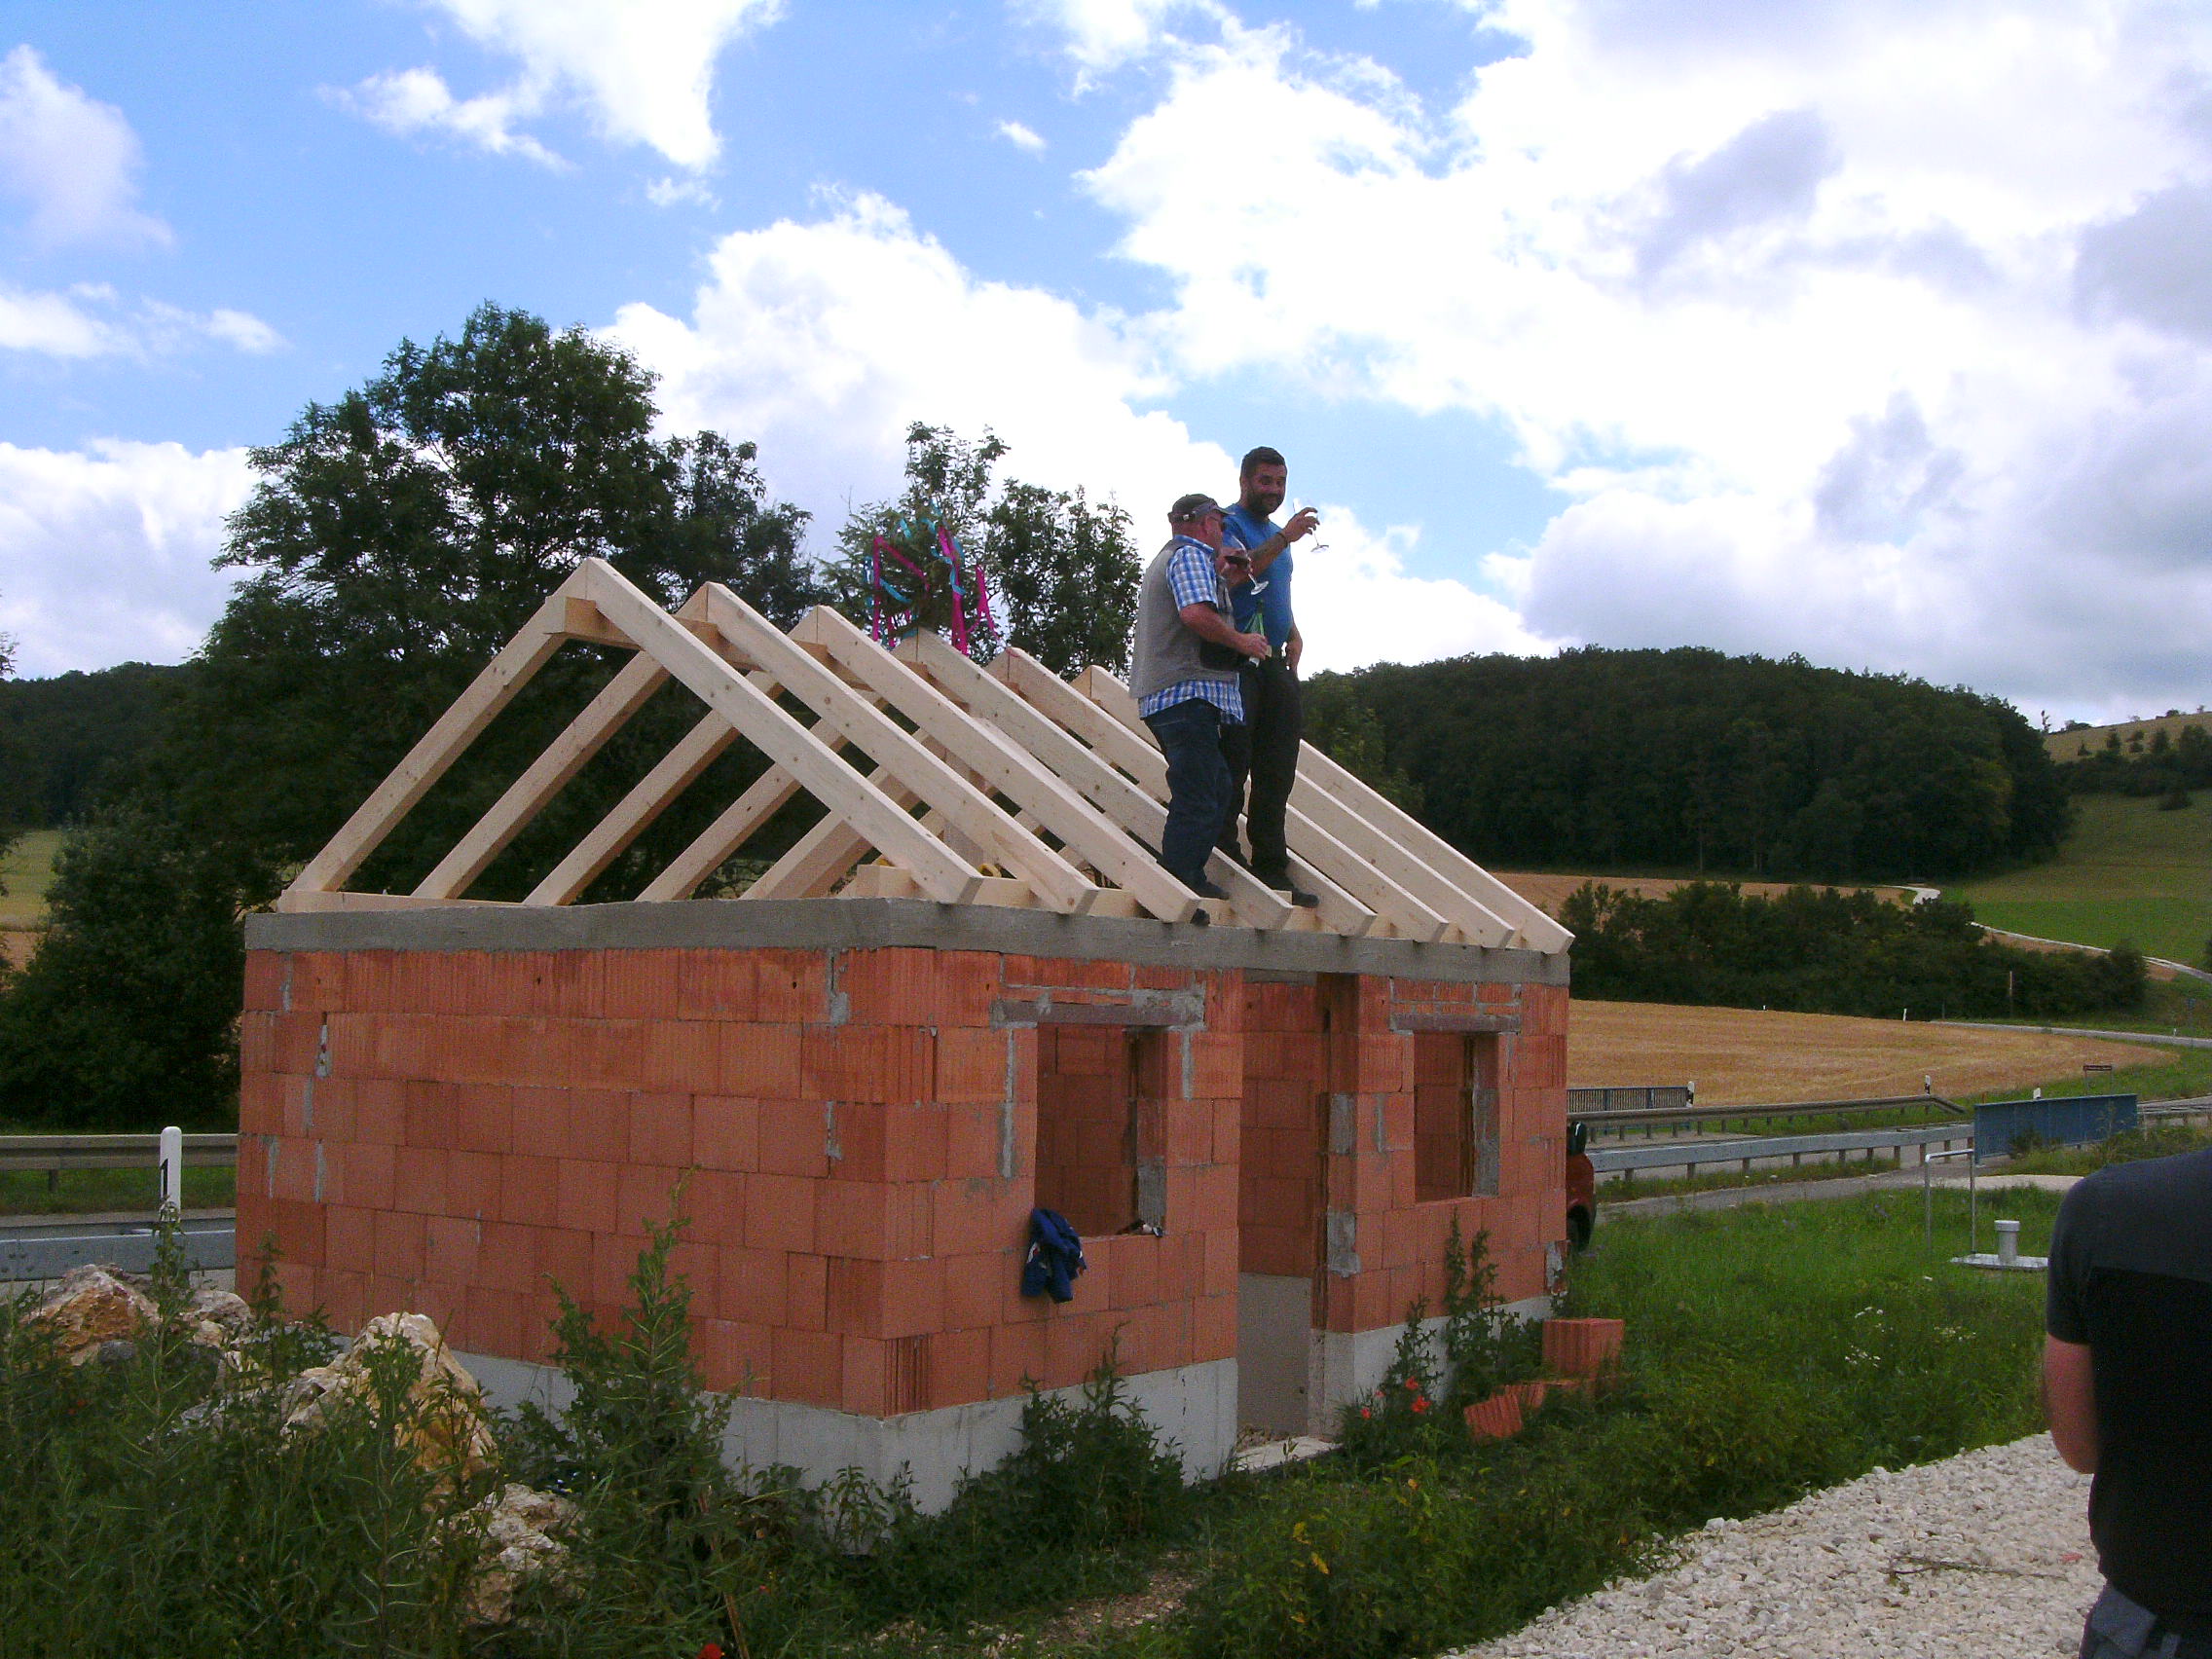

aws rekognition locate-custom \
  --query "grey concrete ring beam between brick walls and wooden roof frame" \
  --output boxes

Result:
[245,898,1568,984]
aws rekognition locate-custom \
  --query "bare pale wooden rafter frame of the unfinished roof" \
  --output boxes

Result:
[278,560,1568,951]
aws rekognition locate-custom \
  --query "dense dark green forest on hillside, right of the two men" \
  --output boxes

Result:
[1308,645,2068,880]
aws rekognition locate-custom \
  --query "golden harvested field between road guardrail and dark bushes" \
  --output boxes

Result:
[1567,998,2165,1106]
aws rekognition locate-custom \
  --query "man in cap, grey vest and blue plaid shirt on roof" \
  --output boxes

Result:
[1130,496,1268,918]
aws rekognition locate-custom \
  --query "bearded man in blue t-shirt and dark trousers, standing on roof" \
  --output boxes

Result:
[1221,445,1318,904]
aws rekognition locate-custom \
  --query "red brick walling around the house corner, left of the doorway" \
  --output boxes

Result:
[239,949,1243,1414]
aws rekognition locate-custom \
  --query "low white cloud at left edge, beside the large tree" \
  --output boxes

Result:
[0,442,252,677]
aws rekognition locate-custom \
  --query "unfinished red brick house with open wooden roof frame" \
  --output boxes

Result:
[239,560,1568,1506]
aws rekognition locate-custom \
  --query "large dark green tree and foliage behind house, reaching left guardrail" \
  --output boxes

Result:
[0,306,816,1128]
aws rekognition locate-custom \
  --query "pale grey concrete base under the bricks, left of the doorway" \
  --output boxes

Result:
[454,1351,1236,1513]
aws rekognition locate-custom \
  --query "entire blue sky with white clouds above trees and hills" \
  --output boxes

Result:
[0,0,2212,715]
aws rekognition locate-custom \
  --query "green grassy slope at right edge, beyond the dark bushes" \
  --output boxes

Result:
[1944,794,2212,965]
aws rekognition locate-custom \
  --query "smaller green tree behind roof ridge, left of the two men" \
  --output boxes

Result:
[828,423,1141,675]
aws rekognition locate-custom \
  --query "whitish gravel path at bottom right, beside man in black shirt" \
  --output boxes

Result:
[1462,1433,2101,1659]
